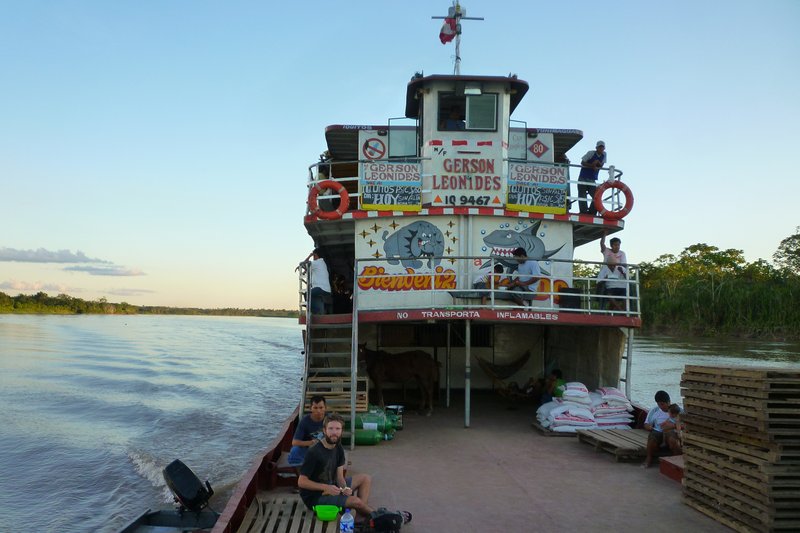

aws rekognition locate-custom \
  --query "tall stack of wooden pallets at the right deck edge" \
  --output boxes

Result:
[681,365,800,531]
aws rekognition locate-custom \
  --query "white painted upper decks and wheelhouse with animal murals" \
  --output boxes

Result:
[301,74,638,326]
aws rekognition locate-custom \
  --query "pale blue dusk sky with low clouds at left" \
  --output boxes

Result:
[0,0,800,309]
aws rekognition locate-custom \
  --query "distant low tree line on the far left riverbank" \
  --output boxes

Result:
[0,292,298,318]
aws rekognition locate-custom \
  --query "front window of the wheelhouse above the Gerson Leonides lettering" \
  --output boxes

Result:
[439,93,497,131]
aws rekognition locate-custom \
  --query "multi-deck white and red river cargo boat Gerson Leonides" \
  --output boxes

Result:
[123,4,723,533]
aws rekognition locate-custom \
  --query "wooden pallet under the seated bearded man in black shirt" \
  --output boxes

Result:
[238,492,339,533]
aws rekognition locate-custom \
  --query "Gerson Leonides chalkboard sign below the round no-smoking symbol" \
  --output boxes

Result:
[359,161,422,211]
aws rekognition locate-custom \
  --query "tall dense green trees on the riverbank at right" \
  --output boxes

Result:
[639,227,800,338]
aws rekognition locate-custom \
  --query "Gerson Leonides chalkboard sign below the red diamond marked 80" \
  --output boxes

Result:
[508,163,569,215]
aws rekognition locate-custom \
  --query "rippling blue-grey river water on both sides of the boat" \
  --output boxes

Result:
[0,315,800,532]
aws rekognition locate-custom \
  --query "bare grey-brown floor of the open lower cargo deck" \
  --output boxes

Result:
[247,393,727,533]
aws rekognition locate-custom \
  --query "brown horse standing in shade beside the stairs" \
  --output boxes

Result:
[358,343,439,416]
